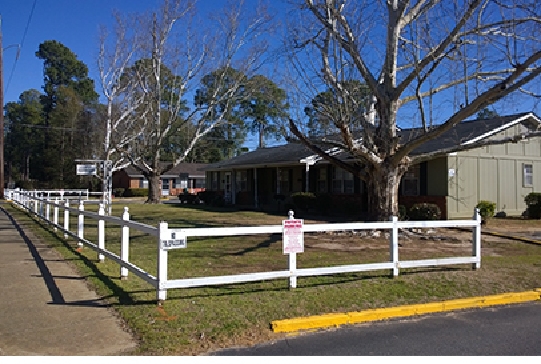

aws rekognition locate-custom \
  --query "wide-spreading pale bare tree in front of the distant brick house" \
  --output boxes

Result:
[109,0,271,203]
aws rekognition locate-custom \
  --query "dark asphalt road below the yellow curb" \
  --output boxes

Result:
[211,302,541,356]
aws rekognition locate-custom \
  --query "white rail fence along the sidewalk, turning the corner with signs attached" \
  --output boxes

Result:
[7,191,481,301]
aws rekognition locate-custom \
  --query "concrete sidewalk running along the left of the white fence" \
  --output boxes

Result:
[0,202,137,356]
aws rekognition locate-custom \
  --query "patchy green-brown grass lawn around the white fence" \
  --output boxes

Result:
[6,202,541,355]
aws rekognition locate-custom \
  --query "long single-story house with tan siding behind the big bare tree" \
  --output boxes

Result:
[201,113,541,219]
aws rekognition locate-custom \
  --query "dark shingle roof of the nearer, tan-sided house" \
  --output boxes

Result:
[204,113,540,170]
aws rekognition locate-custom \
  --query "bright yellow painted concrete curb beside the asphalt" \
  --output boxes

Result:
[271,288,541,332]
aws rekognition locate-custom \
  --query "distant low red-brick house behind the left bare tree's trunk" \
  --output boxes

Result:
[113,162,207,196]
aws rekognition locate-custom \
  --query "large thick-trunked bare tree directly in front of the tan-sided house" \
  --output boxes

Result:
[289,0,541,219]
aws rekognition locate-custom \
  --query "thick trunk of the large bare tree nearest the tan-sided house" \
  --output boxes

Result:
[366,161,407,221]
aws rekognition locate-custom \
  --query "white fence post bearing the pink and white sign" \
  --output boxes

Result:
[282,210,304,288]
